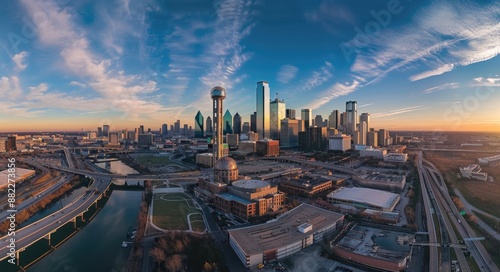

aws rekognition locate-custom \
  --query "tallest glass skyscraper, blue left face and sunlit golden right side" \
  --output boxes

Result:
[256,81,271,139]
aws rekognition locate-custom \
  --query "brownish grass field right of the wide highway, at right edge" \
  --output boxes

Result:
[424,152,500,217]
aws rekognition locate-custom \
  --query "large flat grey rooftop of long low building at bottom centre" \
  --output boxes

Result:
[228,203,344,255]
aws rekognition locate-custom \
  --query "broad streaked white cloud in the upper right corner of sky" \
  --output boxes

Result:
[346,1,500,82]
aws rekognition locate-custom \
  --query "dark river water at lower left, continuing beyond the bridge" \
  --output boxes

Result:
[28,161,143,272]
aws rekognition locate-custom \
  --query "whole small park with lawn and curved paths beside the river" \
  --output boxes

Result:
[153,193,205,232]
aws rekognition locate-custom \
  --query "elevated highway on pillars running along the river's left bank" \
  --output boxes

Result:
[0,179,111,260]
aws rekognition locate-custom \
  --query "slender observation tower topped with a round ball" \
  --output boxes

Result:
[210,86,226,160]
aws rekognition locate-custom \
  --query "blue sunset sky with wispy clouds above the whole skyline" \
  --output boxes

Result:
[0,0,500,132]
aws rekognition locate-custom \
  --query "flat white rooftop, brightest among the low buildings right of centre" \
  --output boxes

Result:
[328,187,399,208]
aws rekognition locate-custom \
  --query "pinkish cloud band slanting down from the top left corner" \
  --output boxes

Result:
[22,0,161,120]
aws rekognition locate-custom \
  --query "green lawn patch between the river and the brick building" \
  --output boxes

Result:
[153,194,201,230]
